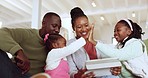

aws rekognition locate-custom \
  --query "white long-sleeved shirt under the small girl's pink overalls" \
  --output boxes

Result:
[45,37,86,70]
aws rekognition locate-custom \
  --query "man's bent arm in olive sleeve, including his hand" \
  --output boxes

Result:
[0,28,30,73]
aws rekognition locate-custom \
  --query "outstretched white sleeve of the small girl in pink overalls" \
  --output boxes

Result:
[47,37,86,61]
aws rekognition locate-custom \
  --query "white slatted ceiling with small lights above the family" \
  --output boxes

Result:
[0,0,148,27]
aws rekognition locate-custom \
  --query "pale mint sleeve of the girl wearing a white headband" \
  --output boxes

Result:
[96,40,142,61]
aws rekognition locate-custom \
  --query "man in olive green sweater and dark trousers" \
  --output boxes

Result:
[0,12,61,78]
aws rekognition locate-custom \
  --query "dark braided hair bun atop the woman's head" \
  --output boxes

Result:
[70,7,85,18]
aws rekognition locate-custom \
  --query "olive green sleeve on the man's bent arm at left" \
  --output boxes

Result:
[0,28,29,55]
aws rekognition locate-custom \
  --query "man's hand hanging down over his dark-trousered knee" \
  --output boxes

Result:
[15,50,30,74]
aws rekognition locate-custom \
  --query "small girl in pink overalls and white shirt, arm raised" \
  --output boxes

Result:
[44,34,86,78]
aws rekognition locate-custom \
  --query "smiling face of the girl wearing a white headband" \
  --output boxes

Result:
[114,23,132,42]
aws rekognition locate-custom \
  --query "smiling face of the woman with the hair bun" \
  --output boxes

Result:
[74,16,91,39]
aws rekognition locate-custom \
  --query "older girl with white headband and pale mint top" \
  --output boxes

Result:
[89,19,147,78]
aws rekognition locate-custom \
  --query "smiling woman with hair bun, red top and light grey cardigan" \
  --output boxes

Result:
[67,7,120,78]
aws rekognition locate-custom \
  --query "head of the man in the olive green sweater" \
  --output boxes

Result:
[39,14,61,38]
